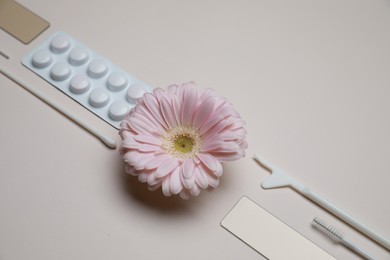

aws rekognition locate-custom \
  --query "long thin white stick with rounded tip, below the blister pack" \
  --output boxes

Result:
[0,67,117,149]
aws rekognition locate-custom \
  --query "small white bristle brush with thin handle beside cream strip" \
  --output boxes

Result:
[313,218,375,260]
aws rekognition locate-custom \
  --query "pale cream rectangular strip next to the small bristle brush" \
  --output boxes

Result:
[221,197,335,260]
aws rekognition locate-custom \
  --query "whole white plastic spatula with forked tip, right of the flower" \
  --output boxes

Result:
[254,154,390,250]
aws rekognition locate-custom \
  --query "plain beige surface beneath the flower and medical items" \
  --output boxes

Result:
[0,0,390,260]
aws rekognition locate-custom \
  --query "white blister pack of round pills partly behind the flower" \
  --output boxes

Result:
[22,32,152,129]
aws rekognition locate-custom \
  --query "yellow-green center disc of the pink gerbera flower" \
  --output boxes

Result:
[162,126,201,160]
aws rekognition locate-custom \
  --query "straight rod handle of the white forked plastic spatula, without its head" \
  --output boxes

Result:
[299,187,390,250]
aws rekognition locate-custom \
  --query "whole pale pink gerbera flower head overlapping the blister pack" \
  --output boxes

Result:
[119,82,247,199]
